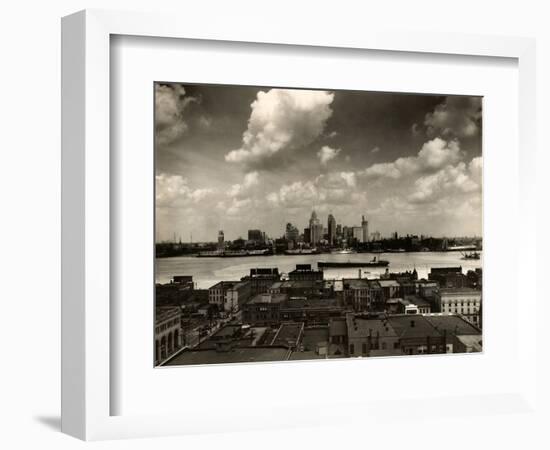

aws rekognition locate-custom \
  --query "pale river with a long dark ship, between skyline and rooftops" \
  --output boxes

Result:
[156,252,483,289]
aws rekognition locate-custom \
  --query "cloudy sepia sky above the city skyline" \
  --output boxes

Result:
[154,83,482,242]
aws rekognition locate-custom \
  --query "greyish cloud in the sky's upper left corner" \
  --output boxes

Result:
[155,83,197,145]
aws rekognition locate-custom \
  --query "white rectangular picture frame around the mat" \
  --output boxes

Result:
[62,10,539,440]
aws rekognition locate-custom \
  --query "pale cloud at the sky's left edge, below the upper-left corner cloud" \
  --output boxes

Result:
[155,173,213,208]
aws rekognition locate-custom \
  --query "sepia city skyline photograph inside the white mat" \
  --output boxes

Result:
[154,81,483,367]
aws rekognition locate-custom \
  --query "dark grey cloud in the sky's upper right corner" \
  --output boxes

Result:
[424,96,481,137]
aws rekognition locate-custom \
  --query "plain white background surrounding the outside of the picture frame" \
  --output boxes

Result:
[0,0,550,450]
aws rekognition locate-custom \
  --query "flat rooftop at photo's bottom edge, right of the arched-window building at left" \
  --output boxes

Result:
[163,346,290,366]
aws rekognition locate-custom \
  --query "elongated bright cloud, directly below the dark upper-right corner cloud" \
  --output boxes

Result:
[360,138,462,180]
